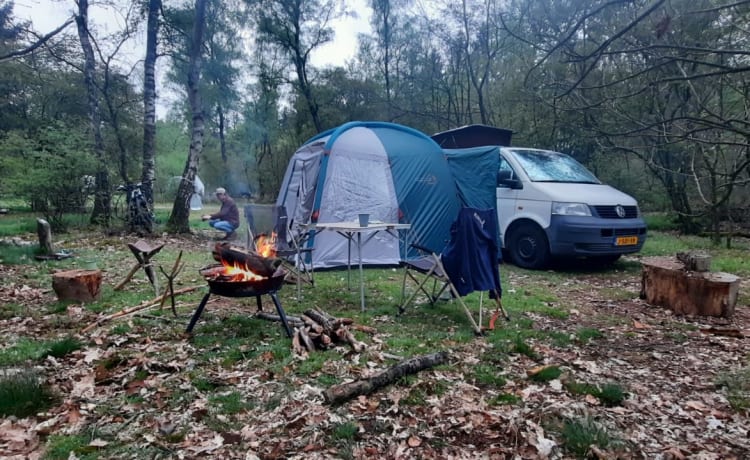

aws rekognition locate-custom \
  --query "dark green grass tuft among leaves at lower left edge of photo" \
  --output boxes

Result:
[0,372,55,418]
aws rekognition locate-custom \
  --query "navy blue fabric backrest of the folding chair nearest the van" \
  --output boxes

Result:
[440,208,501,296]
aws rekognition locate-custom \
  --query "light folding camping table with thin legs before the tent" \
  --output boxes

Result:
[297,221,411,311]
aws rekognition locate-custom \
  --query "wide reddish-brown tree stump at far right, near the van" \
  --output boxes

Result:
[641,257,740,318]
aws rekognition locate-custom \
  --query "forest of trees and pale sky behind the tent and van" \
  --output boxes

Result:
[0,0,750,240]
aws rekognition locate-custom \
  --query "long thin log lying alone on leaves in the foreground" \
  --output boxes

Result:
[323,351,448,404]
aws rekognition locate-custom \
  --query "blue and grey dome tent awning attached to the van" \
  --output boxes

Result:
[276,122,498,268]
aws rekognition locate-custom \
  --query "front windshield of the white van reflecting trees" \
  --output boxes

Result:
[511,149,601,184]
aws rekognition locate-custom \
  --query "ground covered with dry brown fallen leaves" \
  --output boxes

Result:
[0,237,750,460]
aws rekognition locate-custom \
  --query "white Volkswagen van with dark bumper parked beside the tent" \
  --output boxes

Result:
[497,147,646,269]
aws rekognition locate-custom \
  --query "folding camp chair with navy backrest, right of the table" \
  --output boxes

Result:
[399,207,510,334]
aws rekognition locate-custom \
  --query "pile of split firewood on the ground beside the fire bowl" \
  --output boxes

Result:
[256,308,367,356]
